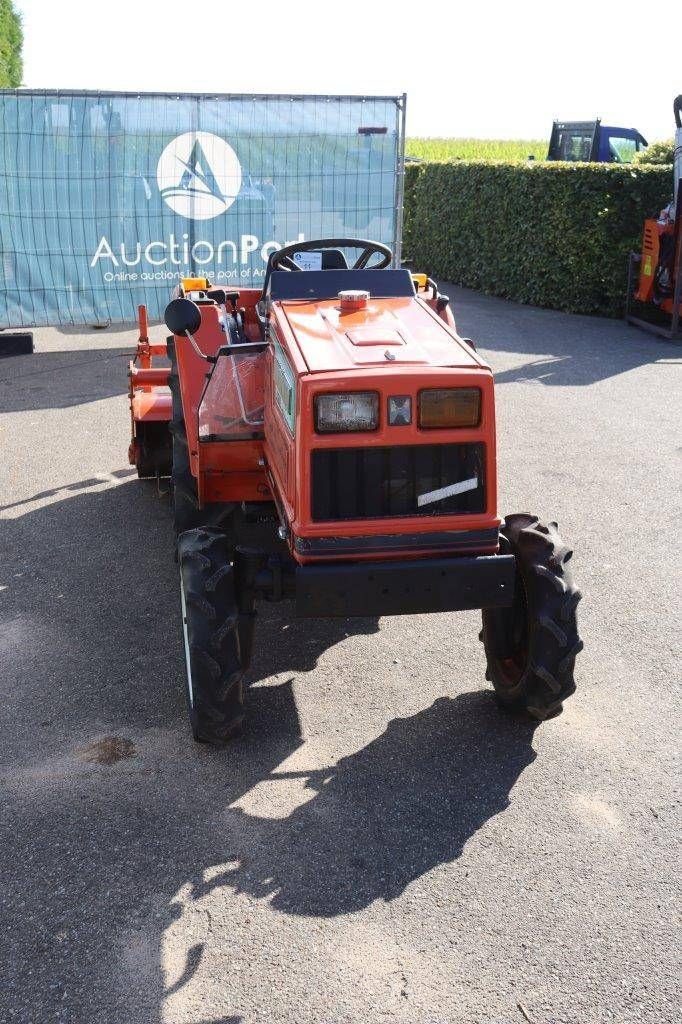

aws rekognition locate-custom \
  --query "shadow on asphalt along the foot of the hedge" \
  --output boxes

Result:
[446,286,680,387]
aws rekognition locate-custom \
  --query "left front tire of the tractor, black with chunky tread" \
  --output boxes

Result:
[178,528,244,743]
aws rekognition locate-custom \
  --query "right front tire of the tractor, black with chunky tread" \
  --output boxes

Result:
[480,513,583,721]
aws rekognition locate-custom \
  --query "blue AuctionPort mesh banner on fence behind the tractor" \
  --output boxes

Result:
[0,90,404,327]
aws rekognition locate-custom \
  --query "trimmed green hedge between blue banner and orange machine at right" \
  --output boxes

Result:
[403,161,673,316]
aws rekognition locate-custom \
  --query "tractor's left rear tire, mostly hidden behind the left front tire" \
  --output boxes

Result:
[167,339,236,536]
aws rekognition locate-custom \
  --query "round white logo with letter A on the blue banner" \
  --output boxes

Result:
[157,131,242,220]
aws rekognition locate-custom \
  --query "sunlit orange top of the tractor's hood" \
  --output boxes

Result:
[282,298,486,374]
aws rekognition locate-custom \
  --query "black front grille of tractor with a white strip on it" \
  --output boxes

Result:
[311,443,485,522]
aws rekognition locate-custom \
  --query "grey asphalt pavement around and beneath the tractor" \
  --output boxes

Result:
[0,289,682,1024]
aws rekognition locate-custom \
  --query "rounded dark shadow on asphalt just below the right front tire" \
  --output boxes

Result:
[193,691,536,918]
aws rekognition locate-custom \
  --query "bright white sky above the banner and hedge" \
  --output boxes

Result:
[15,0,682,141]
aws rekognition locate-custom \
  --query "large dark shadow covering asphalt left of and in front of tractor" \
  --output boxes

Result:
[0,479,536,1024]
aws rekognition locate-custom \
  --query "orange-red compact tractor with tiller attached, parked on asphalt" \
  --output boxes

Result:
[125,239,583,743]
